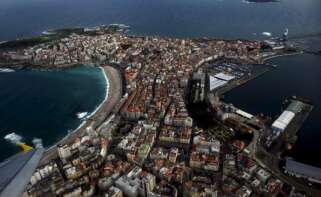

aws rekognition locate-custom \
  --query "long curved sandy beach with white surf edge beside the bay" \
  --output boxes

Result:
[39,65,122,165]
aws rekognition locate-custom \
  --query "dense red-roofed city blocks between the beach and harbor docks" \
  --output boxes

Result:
[1,26,316,197]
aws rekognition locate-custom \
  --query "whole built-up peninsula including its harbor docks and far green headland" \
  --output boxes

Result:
[0,25,321,197]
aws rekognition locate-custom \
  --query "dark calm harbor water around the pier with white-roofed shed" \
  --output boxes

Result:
[224,54,321,167]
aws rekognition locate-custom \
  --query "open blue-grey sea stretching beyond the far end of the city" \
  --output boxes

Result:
[0,0,321,40]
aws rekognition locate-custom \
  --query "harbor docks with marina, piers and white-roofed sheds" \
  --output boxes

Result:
[186,46,320,196]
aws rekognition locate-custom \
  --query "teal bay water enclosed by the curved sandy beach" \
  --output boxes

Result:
[0,65,106,160]
